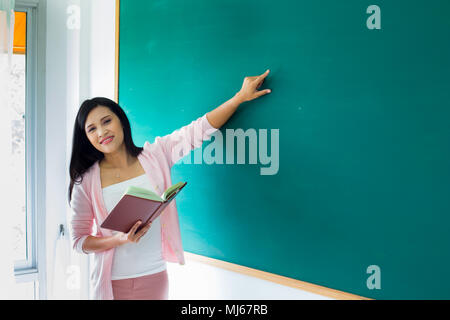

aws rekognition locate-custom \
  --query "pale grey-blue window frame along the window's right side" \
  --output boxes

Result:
[14,0,46,299]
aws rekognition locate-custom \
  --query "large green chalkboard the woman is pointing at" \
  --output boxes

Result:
[119,0,450,299]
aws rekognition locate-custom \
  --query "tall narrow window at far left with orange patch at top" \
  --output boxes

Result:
[8,1,45,299]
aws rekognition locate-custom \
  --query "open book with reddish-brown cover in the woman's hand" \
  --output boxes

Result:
[101,182,187,233]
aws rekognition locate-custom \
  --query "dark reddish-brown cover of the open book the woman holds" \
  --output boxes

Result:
[101,182,186,233]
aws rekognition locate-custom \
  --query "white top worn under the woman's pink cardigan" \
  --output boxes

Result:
[102,174,167,280]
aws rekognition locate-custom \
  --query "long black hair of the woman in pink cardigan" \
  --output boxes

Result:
[69,97,143,206]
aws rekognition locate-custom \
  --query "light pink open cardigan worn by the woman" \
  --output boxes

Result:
[69,114,218,299]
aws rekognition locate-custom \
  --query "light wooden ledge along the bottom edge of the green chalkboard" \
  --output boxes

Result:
[184,251,372,300]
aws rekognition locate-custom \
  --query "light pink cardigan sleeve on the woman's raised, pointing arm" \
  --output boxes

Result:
[155,114,219,167]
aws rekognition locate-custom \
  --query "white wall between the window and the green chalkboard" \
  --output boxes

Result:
[40,0,115,299]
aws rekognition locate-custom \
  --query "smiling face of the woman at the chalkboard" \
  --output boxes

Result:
[84,106,123,153]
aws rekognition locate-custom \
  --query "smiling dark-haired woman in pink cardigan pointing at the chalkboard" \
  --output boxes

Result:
[69,70,270,299]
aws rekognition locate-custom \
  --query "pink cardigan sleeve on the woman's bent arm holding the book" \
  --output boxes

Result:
[69,184,94,254]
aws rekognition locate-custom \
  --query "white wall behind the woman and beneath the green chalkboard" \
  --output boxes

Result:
[42,0,327,299]
